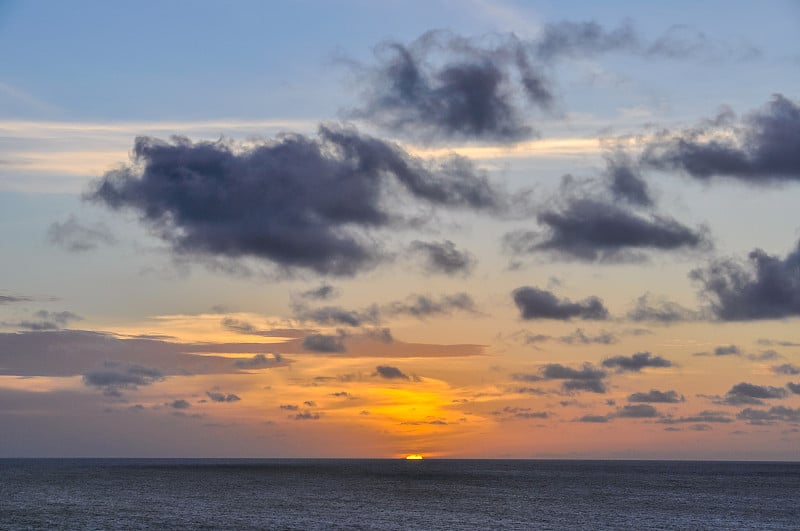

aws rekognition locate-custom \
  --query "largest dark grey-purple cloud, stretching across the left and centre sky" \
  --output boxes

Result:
[85,125,505,276]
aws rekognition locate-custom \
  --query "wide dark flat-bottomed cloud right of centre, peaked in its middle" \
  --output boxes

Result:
[504,197,710,262]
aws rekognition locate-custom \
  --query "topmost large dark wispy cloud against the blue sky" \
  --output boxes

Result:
[350,31,554,142]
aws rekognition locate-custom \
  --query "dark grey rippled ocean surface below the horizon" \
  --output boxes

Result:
[0,459,800,530]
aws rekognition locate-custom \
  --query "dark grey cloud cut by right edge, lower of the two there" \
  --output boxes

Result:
[690,242,800,321]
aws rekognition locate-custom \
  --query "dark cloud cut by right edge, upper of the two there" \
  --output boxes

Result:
[641,94,800,184]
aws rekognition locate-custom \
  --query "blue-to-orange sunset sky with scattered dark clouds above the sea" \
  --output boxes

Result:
[0,0,800,460]
